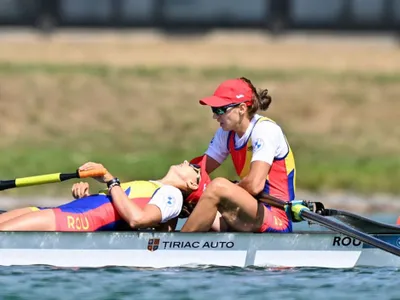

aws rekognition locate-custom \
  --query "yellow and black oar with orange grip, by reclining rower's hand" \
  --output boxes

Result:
[0,169,107,191]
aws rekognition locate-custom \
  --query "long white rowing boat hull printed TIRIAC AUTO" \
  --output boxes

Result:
[0,231,400,268]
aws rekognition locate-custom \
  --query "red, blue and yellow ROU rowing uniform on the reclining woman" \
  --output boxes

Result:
[32,181,183,231]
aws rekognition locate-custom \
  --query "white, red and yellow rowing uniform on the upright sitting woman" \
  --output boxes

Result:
[206,115,296,232]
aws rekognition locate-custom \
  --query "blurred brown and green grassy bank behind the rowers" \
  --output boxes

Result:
[0,63,400,195]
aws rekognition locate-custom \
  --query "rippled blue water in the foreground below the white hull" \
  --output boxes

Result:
[0,266,400,300]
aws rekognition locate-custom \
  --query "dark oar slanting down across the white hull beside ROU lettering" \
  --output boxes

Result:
[258,193,400,256]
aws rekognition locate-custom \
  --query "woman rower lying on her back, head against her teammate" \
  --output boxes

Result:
[0,159,210,231]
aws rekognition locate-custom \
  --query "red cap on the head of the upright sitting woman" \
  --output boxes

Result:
[199,78,253,107]
